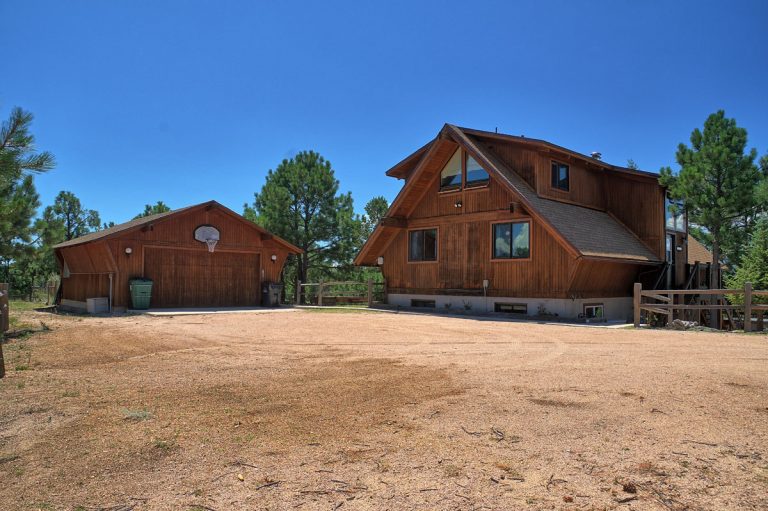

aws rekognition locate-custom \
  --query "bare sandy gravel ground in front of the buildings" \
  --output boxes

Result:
[0,311,768,511]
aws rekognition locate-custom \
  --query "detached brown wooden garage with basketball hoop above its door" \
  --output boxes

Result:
[54,201,301,311]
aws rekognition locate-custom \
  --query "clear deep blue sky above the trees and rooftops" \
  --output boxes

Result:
[0,0,768,222]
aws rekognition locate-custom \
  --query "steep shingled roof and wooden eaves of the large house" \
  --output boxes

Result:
[355,124,659,265]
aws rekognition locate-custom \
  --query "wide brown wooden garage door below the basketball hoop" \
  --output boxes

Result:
[144,247,260,307]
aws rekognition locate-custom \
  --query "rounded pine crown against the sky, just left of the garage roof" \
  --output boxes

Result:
[38,191,101,244]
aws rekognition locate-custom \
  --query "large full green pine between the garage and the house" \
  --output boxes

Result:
[244,151,360,300]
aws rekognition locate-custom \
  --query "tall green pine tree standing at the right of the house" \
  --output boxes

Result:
[660,110,763,282]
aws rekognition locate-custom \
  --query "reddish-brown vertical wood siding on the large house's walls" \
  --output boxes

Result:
[371,135,664,298]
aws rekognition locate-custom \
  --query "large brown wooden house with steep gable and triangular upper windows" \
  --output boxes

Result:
[355,124,706,320]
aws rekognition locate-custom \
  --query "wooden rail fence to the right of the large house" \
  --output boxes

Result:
[634,282,768,332]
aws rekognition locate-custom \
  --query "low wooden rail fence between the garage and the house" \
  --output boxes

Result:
[296,279,386,307]
